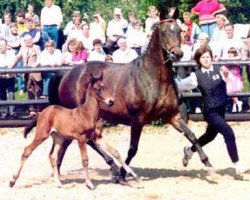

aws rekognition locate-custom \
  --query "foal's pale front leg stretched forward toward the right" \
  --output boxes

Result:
[96,138,139,181]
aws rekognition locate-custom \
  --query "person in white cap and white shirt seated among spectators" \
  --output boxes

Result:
[105,8,128,54]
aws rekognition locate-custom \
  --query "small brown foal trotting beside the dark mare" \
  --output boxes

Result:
[10,75,139,189]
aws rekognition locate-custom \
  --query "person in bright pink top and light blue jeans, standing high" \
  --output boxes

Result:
[192,0,226,39]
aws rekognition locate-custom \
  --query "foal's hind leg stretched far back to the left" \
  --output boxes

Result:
[9,130,49,187]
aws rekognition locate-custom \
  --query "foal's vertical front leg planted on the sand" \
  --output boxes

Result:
[78,139,95,190]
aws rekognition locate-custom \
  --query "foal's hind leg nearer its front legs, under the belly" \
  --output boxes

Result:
[49,133,63,188]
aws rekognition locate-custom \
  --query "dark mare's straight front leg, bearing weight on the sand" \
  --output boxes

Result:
[121,122,143,180]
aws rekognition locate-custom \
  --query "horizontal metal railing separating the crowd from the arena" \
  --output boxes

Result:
[0,60,250,127]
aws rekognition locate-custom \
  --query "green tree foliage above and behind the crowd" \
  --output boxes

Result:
[0,0,250,23]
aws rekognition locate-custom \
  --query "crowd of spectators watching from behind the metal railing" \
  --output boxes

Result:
[0,0,250,117]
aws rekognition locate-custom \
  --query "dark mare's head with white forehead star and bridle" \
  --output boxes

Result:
[159,18,183,61]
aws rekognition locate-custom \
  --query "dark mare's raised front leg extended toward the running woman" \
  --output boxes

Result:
[171,115,212,170]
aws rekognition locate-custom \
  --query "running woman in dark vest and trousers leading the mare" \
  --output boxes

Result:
[177,46,246,174]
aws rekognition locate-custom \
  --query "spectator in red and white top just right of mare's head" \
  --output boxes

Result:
[182,12,201,44]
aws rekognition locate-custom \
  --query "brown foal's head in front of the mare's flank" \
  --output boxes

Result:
[90,74,114,106]
